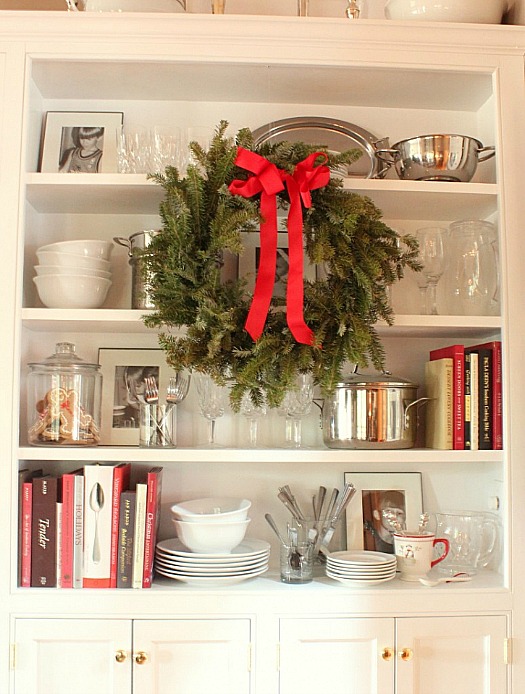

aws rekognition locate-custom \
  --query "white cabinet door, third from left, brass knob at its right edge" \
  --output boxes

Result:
[279,618,392,694]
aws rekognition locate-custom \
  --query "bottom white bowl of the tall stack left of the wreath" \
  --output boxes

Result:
[33,274,111,308]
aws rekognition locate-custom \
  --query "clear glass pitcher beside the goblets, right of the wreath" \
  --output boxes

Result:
[446,219,499,316]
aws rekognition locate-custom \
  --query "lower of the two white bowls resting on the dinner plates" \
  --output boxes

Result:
[173,518,250,554]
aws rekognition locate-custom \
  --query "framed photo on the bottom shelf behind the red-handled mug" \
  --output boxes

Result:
[345,472,423,554]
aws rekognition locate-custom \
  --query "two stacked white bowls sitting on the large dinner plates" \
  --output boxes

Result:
[171,497,252,553]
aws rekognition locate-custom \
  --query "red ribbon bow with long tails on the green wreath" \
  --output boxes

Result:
[229,147,330,345]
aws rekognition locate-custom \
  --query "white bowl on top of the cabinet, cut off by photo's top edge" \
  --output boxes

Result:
[385,0,508,24]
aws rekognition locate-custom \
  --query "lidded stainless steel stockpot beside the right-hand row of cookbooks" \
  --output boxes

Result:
[322,373,429,449]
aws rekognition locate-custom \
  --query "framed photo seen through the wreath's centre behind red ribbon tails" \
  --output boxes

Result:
[239,232,316,298]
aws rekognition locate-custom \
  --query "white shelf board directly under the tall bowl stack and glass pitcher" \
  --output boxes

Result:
[22,308,501,337]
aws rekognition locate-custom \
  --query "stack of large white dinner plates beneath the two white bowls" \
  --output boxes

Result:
[155,538,270,585]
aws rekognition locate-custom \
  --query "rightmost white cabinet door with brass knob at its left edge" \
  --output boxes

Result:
[396,616,507,694]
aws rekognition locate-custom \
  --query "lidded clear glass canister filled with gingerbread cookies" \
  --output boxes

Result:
[27,342,102,446]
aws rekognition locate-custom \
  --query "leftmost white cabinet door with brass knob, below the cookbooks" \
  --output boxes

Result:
[14,619,132,694]
